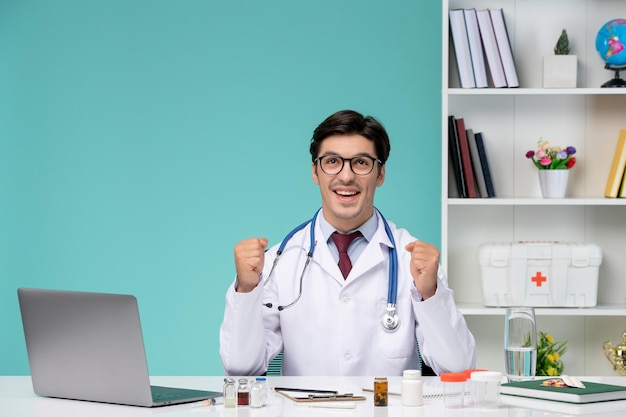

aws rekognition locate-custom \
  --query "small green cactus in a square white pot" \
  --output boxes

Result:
[543,29,578,88]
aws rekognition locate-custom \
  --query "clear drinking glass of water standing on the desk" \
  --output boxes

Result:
[504,307,537,381]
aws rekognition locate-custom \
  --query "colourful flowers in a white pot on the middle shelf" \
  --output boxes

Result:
[526,138,576,198]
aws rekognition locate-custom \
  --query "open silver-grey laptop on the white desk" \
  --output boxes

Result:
[17,288,222,407]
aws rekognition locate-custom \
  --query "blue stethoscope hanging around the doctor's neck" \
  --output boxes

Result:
[263,209,400,332]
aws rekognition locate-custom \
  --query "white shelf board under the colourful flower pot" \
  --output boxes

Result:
[447,197,626,206]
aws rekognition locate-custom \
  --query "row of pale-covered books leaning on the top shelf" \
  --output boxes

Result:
[449,9,519,88]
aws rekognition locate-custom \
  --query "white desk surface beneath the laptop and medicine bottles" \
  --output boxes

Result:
[0,376,626,417]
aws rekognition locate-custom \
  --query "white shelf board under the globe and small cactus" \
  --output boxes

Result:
[444,88,626,96]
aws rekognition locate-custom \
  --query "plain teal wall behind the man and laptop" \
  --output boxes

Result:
[0,0,441,375]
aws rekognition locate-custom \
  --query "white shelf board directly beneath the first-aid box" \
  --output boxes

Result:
[457,303,626,317]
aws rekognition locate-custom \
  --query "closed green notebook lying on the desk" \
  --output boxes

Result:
[500,379,626,404]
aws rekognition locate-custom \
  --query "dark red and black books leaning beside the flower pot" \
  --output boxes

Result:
[448,116,496,198]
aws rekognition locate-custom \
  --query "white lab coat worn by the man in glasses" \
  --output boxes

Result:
[220,213,475,376]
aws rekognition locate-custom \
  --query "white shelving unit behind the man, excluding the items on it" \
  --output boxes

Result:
[441,0,626,375]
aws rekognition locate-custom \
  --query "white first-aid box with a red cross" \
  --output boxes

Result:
[478,242,602,307]
